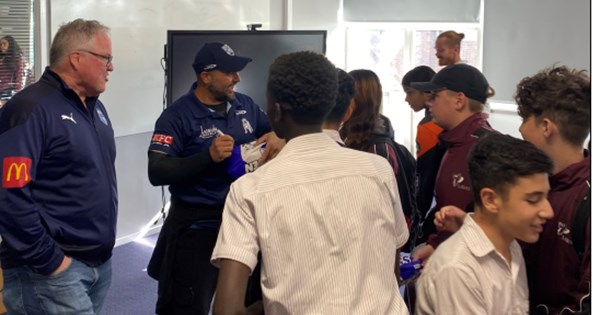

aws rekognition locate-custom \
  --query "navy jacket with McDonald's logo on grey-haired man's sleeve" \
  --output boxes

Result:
[0,69,117,275]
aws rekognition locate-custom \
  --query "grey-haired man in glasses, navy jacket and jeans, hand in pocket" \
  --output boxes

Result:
[0,19,117,314]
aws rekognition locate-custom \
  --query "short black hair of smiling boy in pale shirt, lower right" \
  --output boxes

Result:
[469,132,554,206]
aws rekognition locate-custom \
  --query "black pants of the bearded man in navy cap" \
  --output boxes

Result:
[148,201,262,315]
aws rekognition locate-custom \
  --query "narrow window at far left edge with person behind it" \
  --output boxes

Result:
[0,0,35,105]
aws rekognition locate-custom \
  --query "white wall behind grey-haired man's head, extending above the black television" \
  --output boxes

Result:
[50,0,271,136]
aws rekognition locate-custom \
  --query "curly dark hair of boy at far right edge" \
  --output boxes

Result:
[515,66,592,145]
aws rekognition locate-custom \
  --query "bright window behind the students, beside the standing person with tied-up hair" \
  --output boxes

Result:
[346,23,481,153]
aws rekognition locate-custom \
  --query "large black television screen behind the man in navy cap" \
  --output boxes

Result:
[165,30,327,109]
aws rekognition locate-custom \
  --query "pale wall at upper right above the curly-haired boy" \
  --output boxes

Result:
[483,0,591,101]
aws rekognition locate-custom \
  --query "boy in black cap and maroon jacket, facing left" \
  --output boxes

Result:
[410,64,494,259]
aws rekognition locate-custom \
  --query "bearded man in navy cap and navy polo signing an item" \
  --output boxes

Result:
[148,43,283,314]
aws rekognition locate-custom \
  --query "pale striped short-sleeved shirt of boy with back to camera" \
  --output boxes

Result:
[211,132,408,315]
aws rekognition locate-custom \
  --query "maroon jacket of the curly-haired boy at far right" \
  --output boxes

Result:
[524,155,592,315]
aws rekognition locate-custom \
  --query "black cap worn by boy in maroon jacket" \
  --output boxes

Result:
[410,64,490,103]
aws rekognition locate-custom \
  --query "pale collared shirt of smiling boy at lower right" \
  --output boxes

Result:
[417,214,529,315]
